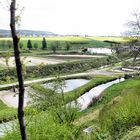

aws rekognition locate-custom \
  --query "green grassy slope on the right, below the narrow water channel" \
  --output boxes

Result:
[87,78,140,140]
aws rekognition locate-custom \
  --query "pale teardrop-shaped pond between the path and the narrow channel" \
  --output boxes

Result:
[43,79,89,92]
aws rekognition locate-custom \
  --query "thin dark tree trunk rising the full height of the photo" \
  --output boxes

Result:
[10,0,27,140]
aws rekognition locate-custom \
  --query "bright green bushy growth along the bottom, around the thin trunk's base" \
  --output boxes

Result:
[1,112,82,140]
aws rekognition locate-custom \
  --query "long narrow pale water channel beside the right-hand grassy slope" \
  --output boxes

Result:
[68,78,125,111]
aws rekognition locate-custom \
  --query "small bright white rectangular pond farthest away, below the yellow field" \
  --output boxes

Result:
[87,48,112,55]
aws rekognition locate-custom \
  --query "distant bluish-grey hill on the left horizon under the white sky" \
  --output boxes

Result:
[0,29,57,37]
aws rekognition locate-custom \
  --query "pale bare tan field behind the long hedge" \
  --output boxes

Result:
[0,55,104,69]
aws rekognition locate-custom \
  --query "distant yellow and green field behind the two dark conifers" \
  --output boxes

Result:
[0,37,123,50]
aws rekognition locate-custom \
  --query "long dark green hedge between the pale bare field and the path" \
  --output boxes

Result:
[0,56,117,81]
